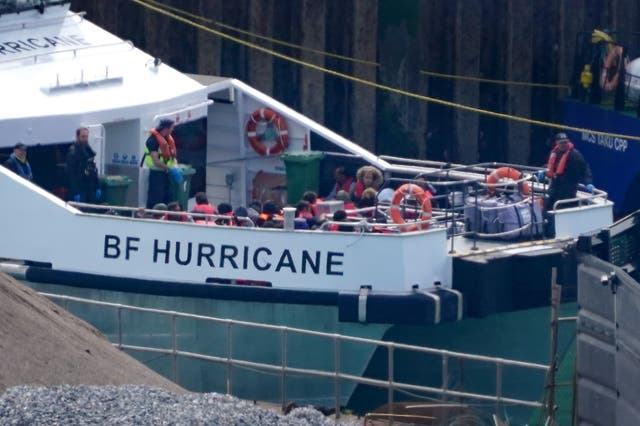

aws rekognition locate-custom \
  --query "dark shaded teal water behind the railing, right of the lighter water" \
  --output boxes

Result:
[349,303,577,425]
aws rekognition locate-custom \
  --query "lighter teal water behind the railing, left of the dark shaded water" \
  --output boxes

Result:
[27,283,389,406]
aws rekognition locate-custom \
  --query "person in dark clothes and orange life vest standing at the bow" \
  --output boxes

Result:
[545,133,594,210]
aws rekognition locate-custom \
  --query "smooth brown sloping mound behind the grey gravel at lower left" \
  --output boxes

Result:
[0,272,184,396]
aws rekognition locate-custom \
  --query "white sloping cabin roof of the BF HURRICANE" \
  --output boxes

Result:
[0,5,206,143]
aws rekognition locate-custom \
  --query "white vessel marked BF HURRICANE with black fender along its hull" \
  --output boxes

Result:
[0,1,612,420]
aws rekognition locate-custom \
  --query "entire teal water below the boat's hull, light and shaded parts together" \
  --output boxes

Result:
[28,283,576,424]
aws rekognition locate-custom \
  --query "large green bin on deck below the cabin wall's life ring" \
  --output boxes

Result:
[282,151,324,205]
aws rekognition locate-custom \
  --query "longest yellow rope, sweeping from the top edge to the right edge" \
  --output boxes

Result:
[130,0,640,141]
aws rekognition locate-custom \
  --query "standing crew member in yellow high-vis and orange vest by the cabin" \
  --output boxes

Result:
[144,119,182,208]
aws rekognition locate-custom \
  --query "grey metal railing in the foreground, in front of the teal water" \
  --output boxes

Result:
[40,293,549,416]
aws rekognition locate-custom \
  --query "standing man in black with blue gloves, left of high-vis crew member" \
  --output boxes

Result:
[67,127,102,203]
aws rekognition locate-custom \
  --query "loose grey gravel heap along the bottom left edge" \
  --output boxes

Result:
[0,385,361,426]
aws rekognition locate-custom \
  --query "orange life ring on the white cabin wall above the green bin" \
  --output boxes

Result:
[247,108,289,156]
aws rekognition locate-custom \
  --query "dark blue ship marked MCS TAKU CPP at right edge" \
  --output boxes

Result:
[562,30,640,216]
